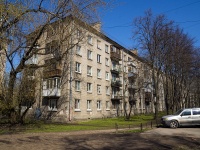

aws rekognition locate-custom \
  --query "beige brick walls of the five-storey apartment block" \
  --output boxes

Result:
[25,18,164,121]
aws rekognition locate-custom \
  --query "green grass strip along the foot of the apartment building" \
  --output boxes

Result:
[0,115,157,134]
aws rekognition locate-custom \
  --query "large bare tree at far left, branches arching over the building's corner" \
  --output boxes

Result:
[0,0,106,123]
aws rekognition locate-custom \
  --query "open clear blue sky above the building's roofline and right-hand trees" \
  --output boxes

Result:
[100,0,200,49]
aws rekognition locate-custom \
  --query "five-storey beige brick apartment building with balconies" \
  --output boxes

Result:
[24,16,164,121]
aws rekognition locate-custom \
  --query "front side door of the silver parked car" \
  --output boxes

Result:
[179,109,192,125]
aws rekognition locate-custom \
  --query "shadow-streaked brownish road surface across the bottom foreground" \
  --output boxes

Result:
[0,128,200,150]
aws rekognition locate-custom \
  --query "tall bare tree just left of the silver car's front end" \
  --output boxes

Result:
[134,11,175,119]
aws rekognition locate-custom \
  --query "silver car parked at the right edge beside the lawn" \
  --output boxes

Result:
[161,108,200,128]
